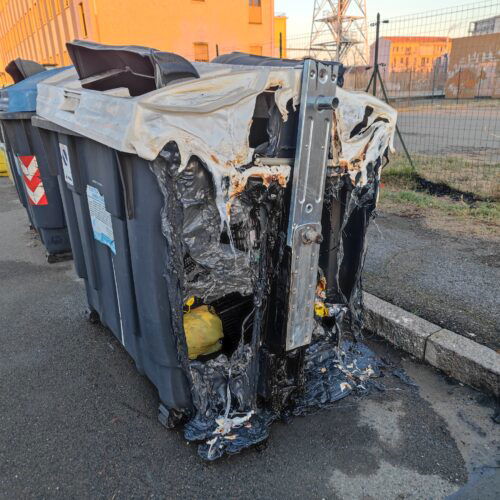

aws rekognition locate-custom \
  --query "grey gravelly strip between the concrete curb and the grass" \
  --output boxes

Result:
[364,213,500,349]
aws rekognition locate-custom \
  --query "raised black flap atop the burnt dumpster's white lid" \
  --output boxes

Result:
[66,40,199,96]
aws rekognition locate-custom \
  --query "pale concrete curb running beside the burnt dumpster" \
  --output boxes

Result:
[363,292,500,396]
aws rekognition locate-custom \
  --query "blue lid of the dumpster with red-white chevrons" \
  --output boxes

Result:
[0,66,69,113]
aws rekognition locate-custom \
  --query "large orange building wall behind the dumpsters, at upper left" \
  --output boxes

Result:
[0,0,275,86]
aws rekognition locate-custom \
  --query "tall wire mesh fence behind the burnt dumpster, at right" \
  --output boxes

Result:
[246,0,500,199]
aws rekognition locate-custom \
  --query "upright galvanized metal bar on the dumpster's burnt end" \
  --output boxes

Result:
[286,59,338,351]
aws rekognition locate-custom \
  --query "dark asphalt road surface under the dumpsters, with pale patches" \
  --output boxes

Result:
[0,179,500,499]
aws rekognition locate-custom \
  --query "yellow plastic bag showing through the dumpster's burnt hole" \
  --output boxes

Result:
[184,306,224,359]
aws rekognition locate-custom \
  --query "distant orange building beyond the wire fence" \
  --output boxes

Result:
[370,36,451,73]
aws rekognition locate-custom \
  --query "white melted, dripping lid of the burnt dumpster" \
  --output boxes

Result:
[37,59,397,193]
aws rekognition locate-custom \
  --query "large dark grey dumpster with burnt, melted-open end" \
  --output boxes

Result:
[37,43,396,459]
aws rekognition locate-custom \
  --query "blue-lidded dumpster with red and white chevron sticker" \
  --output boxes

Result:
[0,60,71,262]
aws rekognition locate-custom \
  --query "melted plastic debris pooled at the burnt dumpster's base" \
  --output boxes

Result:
[184,338,384,461]
